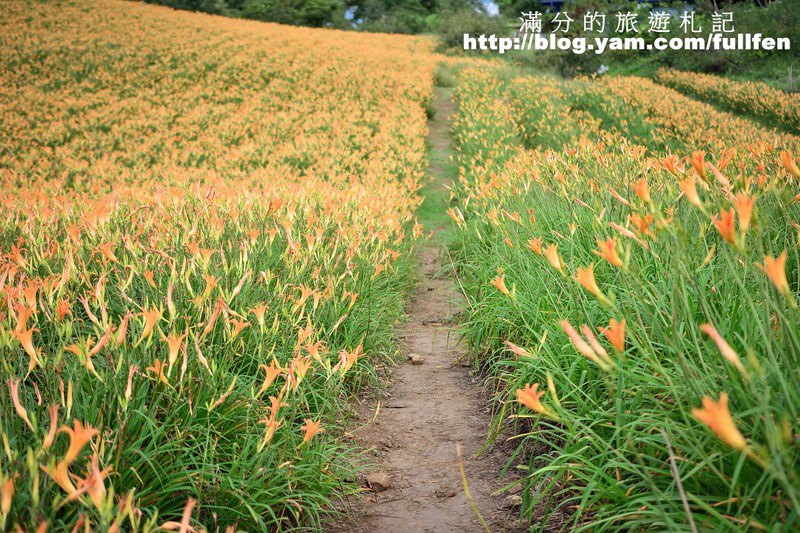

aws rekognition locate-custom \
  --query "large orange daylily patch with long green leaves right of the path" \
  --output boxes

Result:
[449,70,800,531]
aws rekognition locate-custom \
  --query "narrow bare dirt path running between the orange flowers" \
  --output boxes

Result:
[335,90,510,533]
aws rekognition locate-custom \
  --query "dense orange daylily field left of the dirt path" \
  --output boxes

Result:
[0,0,435,531]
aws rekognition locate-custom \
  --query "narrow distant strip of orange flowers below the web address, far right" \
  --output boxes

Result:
[655,69,800,133]
